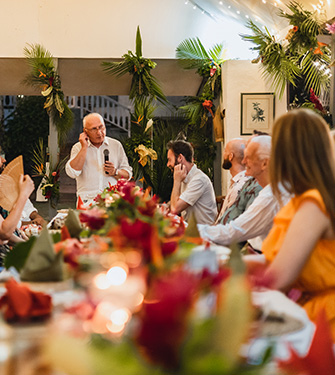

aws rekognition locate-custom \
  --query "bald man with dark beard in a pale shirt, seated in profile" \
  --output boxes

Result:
[215,138,258,224]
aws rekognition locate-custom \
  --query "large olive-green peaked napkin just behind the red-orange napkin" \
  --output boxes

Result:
[20,228,64,281]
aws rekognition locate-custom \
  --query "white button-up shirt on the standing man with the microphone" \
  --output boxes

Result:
[65,137,132,202]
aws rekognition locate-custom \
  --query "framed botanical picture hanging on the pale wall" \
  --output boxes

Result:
[241,92,275,135]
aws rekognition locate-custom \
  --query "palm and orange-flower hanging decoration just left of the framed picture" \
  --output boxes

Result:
[176,38,225,127]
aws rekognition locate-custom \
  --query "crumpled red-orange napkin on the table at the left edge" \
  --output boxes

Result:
[0,278,52,321]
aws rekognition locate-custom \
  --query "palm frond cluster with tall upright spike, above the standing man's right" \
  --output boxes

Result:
[102,26,167,104]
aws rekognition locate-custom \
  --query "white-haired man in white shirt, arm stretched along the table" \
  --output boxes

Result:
[198,135,288,250]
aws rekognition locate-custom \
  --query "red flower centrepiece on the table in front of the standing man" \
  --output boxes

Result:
[79,179,185,266]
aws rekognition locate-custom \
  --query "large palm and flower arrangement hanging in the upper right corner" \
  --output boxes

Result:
[242,1,330,100]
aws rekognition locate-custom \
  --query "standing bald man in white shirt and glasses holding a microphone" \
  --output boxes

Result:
[65,113,132,204]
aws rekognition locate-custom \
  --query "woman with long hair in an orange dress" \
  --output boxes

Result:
[262,109,335,340]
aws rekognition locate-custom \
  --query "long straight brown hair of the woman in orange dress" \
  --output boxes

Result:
[270,109,335,230]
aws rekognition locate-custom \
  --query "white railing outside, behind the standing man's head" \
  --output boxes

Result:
[65,95,131,136]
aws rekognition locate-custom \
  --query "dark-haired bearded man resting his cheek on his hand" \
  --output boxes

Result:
[167,140,217,224]
